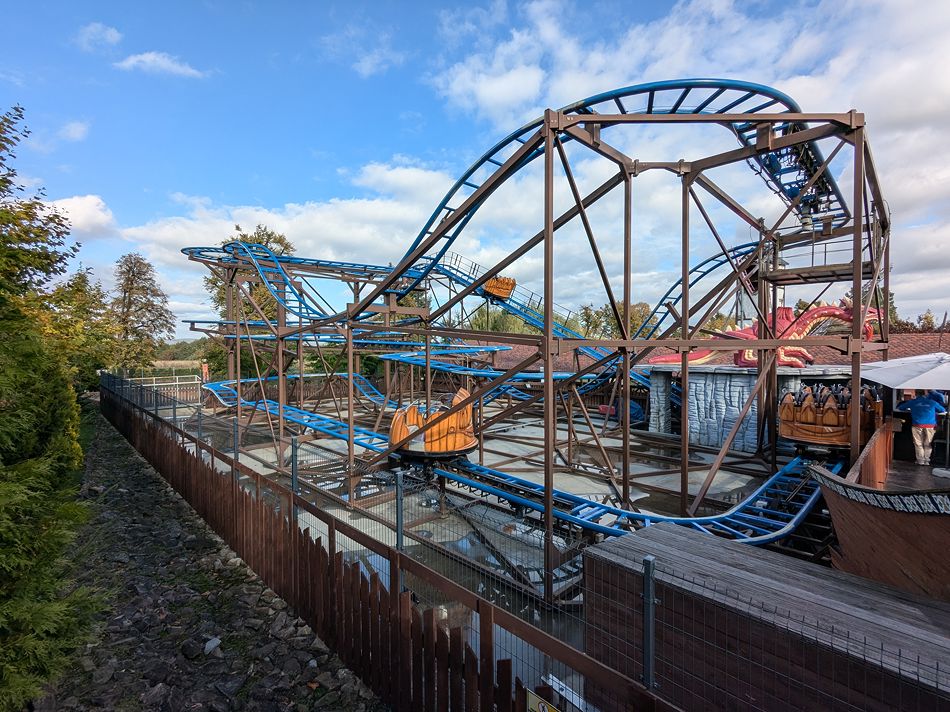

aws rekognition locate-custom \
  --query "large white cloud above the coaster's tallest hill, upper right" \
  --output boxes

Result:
[429,0,950,320]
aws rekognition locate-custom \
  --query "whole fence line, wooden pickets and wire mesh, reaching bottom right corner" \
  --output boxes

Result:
[102,374,950,711]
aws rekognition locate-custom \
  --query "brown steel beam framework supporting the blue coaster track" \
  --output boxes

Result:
[192,103,890,564]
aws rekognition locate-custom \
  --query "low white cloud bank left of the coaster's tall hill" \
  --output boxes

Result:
[76,157,452,338]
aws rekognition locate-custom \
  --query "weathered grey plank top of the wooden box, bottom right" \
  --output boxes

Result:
[586,525,950,684]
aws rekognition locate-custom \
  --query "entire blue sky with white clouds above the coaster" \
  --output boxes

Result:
[0,0,950,335]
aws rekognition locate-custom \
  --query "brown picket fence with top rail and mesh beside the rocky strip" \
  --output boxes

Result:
[101,374,675,712]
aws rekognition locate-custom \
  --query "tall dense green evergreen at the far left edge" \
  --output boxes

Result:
[0,107,91,710]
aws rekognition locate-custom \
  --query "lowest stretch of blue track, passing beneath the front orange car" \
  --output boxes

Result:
[203,379,841,545]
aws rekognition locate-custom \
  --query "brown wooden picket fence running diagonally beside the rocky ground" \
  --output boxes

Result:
[101,384,675,712]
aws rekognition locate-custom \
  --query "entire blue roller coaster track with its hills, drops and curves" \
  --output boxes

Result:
[183,79,850,544]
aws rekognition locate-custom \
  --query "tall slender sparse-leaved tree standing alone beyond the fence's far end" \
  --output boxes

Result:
[112,252,175,368]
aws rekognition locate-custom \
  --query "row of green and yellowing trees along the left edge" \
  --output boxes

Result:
[0,106,173,710]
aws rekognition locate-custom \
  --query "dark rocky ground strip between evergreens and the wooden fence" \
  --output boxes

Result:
[34,400,385,712]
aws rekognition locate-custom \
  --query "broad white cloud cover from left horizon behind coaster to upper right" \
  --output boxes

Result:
[57,0,950,336]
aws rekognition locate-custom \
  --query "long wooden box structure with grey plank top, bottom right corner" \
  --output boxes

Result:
[584,524,950,710]
